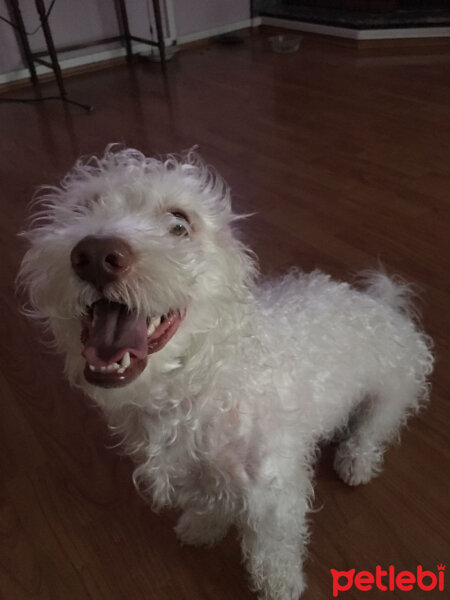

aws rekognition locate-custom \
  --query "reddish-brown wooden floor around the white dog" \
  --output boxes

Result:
[0,29,450,600]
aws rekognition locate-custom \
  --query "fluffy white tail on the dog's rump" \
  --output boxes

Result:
[358,269,420,321]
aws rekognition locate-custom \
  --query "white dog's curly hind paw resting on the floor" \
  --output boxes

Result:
[334,442,382,486]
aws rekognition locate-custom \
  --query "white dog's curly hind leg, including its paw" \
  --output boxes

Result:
[334,382,421,486]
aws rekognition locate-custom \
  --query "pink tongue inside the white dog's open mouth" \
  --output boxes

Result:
[83,300,147,366]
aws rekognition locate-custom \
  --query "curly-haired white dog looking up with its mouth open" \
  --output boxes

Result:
[19,147,433,600]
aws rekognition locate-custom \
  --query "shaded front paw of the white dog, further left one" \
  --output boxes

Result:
[175,511,228,546]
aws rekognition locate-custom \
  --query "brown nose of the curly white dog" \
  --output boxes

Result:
[70,236,135,288]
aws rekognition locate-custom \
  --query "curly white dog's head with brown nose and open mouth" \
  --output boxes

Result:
[19,149,252,388]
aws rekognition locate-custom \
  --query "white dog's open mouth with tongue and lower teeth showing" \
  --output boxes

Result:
[81,299,184,388]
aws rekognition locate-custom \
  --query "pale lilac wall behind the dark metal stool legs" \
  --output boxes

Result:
[0,0,250,74]
